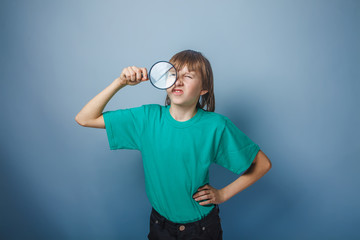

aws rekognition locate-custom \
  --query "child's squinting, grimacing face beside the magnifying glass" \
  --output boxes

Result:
[166,66,208,107]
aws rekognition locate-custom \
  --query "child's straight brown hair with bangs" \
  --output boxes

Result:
[165,50,215,112]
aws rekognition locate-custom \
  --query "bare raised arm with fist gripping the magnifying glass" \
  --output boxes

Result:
[75,66,148,128]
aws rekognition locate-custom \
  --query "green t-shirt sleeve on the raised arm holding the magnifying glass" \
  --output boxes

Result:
[103,106,145,150]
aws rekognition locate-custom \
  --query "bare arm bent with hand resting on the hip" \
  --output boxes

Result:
[193,150,272,205]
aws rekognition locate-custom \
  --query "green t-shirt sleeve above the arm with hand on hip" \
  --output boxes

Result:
[214,118,260,174]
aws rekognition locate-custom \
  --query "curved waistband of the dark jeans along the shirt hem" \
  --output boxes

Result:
[151,204,220,228]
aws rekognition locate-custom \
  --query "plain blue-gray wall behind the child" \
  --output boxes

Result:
[0,0,360,240]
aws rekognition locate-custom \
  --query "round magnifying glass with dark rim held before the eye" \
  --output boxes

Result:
[149,61,177,90]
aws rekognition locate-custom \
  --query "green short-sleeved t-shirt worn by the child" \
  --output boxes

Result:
[103,104,260,223]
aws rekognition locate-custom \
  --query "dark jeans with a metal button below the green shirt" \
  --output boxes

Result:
[148,205,223,240]
